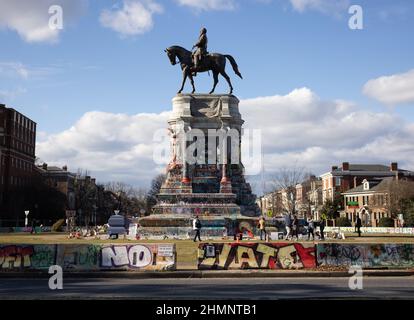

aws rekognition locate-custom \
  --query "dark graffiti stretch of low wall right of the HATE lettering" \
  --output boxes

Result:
[316,243,414,268]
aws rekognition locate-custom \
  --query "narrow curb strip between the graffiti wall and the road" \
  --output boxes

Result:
[0,270,414,279]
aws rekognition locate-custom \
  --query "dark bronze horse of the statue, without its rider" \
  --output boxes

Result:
[164,46,243,94]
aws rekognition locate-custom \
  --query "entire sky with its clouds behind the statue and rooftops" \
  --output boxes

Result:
[0,0,414,193]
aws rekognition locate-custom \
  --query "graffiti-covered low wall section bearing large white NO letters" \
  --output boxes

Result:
[0,244,176,272]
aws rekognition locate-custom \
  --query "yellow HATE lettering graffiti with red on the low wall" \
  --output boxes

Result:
[198,243,316,270]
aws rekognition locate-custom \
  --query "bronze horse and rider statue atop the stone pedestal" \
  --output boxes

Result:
[164,28,243,94]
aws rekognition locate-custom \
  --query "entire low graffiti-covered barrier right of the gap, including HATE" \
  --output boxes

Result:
[198,243,414,270]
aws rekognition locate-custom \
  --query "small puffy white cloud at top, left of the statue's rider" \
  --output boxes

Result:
[100,0,163,36]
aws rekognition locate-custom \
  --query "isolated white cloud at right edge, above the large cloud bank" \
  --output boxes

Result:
[363,69,414,105]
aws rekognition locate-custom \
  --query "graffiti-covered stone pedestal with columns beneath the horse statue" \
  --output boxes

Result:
[139,94,260,237]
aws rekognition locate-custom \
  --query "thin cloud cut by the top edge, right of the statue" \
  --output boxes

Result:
[289,0,350,15]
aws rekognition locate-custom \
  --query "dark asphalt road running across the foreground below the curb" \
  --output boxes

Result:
[0,276,414,300]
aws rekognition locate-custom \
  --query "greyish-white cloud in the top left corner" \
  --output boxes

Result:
[0,0,87,43]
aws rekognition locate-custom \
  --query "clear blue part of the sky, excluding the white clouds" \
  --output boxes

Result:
[0,0,414,189]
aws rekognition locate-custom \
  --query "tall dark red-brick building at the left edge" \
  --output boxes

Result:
[0,104,36,219]
